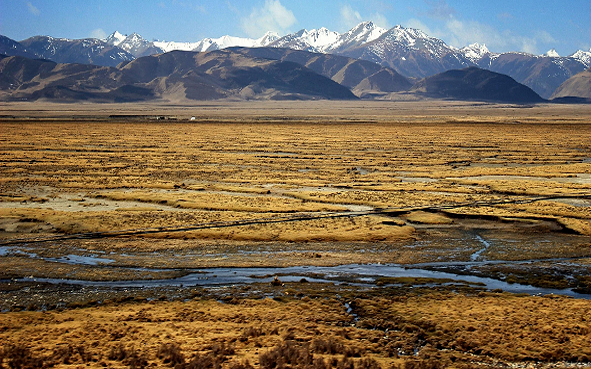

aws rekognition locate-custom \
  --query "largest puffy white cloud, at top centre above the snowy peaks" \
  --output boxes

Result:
[241,0,297,37]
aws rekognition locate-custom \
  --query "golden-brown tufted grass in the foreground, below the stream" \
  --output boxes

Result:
[0,286,591,368]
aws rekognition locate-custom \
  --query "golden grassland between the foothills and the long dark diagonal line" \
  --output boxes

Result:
[0,103,591,241]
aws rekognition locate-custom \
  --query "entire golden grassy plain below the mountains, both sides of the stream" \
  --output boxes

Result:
[0,101,591,368]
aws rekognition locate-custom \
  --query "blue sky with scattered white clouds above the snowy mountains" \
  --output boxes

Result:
[0,0,591,55]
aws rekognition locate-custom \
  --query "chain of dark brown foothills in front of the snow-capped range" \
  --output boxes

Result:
[0,48,545,103]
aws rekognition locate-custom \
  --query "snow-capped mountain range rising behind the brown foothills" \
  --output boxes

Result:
[0,22,591,98]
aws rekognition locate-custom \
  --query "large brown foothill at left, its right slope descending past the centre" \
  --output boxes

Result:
[0,50,356,102]
